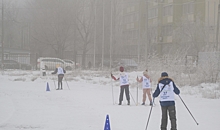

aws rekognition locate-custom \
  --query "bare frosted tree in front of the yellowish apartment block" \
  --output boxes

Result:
[174,17,210,55]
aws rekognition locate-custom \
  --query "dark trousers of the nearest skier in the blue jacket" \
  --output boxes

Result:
[160,106,177,130]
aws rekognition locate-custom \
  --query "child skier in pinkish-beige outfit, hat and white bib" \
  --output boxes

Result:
[137,70,153,105]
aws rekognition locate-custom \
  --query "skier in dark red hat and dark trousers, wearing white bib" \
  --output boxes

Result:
[111,66,130,105]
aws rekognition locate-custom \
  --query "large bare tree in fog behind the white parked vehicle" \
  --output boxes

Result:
[28,0,78,58]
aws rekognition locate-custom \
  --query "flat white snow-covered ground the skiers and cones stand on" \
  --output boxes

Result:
[0,71,220,130]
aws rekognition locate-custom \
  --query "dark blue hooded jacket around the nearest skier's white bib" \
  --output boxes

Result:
[153,77,180,106]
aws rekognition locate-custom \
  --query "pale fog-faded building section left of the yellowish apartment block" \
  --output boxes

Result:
[123,0,146,56]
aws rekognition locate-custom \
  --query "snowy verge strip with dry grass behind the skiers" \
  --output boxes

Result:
[0,70,220,99]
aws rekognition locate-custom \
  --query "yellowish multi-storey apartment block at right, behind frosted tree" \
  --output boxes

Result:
[148,0,219,55]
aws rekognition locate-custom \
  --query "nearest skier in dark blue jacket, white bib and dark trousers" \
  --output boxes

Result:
[153,72,180,130]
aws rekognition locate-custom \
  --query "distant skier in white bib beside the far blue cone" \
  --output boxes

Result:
[51,65,66,90]
